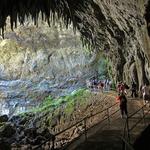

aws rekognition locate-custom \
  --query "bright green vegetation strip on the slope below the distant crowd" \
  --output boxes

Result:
[24,89,91,114]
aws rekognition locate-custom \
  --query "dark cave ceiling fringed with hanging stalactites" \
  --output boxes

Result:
[0,0,150,50]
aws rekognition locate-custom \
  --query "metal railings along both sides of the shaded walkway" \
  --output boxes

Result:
[32,99,150,150]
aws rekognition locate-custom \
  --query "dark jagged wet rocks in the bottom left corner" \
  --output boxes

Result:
[0,115,53,150]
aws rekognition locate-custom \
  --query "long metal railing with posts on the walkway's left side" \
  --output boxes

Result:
[30,102,120,150]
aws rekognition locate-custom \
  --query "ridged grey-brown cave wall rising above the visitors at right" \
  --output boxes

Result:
[79,0,150,86]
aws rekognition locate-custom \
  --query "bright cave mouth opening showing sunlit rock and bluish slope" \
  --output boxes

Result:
[0,18,111,116]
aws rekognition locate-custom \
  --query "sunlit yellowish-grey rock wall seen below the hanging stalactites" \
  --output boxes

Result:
[0,24,96,84]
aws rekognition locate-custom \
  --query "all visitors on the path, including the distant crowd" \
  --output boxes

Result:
[86,77,150,118]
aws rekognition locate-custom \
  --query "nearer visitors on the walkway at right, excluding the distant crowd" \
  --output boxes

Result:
[116,82,150,118]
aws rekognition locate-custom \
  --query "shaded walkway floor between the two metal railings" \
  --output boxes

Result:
[68,99,150,150]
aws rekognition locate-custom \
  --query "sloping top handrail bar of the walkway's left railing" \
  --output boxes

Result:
[33,99,119,150]
